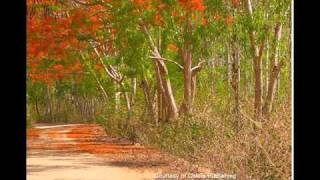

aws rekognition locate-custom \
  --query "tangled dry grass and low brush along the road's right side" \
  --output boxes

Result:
[101,95,291,179]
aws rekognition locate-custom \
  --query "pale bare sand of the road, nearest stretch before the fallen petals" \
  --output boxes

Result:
[27,154,156,180]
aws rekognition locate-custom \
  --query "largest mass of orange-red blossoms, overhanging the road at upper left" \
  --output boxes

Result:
[27,0,107,85]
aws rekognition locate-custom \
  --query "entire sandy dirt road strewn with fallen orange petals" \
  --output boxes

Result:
[27,124,170,180]
